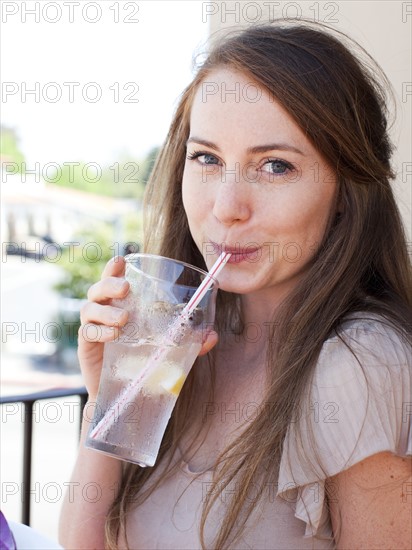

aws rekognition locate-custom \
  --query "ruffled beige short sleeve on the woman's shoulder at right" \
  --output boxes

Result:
[277,314,412,537]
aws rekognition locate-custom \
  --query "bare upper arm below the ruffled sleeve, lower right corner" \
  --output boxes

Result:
[326,452,412,550]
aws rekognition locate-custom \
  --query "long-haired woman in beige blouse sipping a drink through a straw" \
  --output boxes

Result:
[61,22,412,549]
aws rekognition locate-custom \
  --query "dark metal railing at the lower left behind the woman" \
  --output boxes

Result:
[0,387,87,525]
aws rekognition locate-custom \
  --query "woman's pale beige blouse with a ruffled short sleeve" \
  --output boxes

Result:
[127,314,412,550]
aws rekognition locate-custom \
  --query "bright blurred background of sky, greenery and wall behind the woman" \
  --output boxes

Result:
[0,0,412,538]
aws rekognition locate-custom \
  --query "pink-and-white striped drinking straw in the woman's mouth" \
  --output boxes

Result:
[90,252,231,439]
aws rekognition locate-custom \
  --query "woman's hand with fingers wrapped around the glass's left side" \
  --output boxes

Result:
[78,256,129,401]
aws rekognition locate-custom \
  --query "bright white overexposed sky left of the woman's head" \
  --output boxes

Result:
[0,0,208,165]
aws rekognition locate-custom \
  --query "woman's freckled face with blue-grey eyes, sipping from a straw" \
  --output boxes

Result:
[183,68,337,302]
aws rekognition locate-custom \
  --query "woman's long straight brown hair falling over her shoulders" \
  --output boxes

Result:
[106,21,412,549]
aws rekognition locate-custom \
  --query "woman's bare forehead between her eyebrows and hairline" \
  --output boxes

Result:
[190,68,306,148]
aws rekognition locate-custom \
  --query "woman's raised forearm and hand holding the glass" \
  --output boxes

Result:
[59,258,128,550]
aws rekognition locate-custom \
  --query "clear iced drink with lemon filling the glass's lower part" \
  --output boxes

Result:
[87,342,201,466]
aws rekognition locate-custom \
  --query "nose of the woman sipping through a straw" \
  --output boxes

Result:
[213,179,251,225]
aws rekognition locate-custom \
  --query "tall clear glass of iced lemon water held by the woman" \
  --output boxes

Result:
[86,254,218,466]
